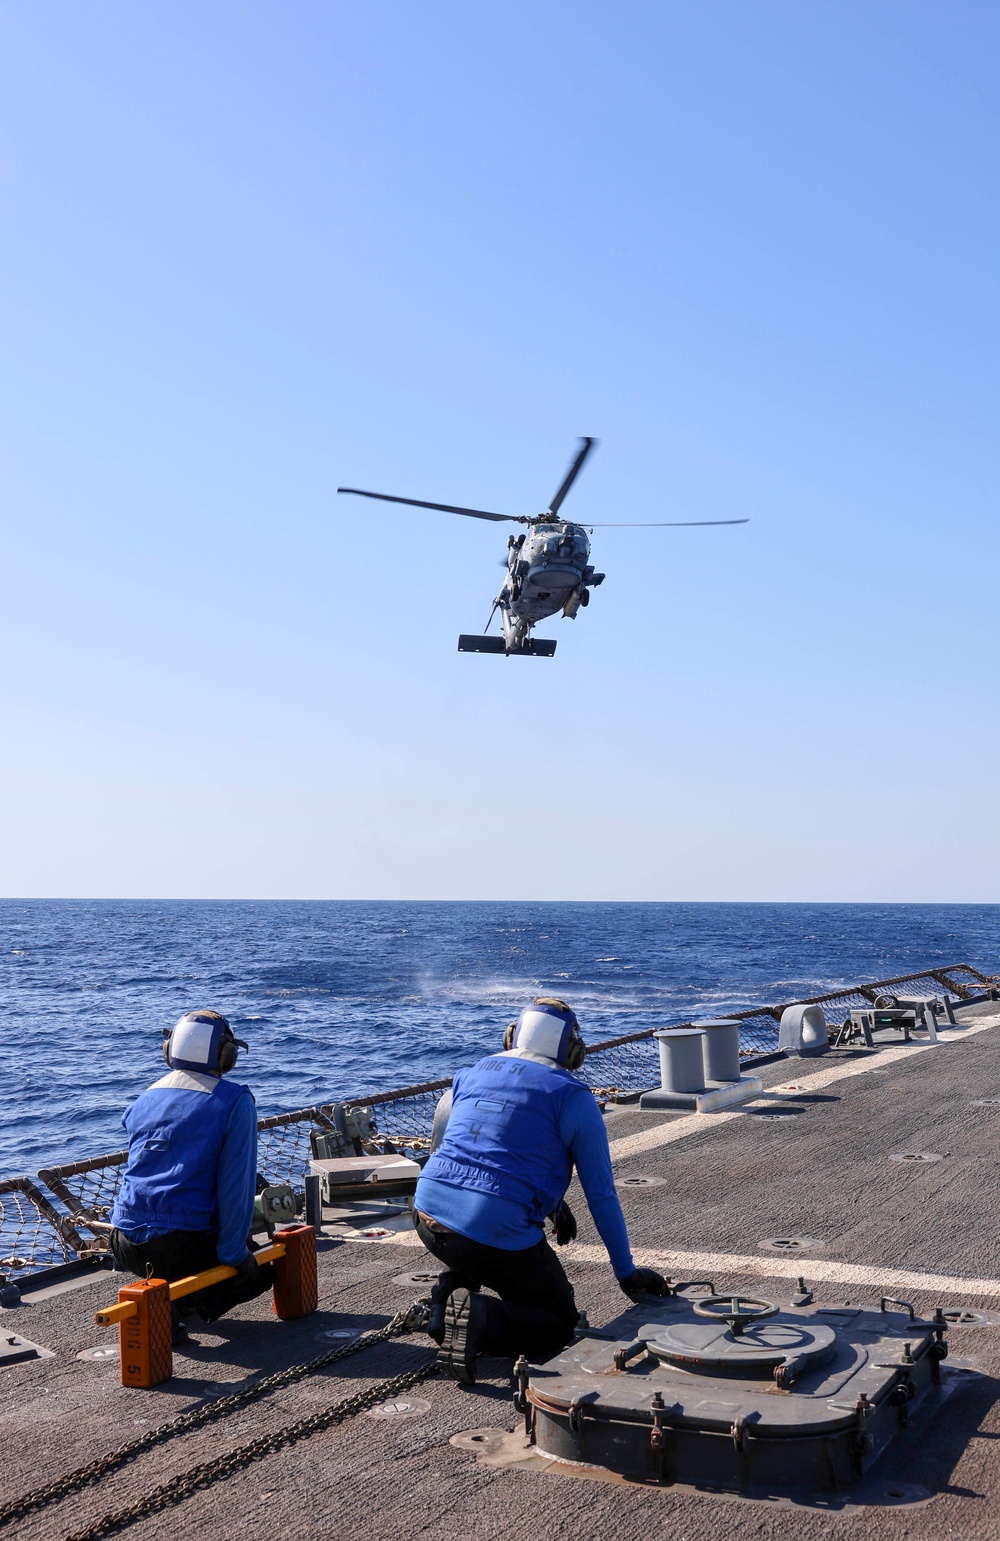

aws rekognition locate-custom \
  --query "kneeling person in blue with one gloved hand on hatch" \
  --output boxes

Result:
[413,997,667,1384]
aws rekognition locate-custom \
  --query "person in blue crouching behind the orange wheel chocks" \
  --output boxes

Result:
[111,1011,273,1344]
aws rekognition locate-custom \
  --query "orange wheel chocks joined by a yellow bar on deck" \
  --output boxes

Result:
[94,1225,319,1387]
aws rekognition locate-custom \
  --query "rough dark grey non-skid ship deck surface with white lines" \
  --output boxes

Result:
[0,1008,1000,1541]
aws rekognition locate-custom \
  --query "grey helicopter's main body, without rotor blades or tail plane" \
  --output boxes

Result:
[496,515,604,649]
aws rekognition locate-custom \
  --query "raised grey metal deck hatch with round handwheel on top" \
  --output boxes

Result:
[527,1296,943,1492]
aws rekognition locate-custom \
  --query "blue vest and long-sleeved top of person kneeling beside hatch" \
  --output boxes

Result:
[414,1054,635,1279]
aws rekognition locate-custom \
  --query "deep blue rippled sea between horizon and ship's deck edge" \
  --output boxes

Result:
[0,900,1000,1176]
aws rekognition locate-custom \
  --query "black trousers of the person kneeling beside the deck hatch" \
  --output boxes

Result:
[413,1213,579,1362]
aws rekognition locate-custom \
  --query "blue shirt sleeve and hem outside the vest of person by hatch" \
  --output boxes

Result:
[413,1082,635,1279]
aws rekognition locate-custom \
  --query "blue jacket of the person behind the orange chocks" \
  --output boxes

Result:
[111,1071,257,1267]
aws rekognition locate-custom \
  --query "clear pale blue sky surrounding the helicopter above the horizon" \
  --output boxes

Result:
[0,0,1000,901]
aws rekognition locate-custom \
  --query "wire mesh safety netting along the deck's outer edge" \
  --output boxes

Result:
[7,963,997,1285]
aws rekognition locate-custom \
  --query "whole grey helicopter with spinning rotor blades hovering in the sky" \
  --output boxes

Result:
[337,439,749,658]
